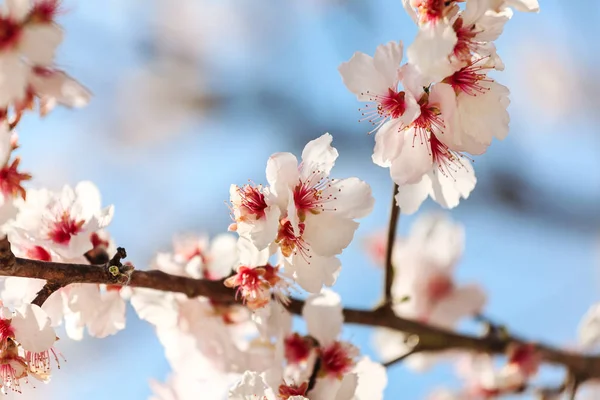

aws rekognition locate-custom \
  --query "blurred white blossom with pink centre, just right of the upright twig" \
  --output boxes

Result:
[375,214,485,370]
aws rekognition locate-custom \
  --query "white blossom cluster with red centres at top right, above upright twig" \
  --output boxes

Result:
[339,0,539,214]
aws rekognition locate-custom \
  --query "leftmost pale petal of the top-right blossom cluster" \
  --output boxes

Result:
[338,52,398,101]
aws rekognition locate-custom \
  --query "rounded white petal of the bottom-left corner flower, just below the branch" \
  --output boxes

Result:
[11,304,56,353]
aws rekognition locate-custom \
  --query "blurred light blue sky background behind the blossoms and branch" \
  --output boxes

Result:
[9,0,600,400]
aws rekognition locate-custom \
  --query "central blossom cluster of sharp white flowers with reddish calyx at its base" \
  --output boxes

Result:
[229,133,375,307]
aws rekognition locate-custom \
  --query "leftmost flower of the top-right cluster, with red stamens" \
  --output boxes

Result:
[338,42,420,143]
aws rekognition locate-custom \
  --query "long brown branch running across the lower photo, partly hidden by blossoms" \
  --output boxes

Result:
[0,239,600,383]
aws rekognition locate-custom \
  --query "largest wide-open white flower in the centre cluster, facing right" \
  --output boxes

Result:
[267,134,374,292]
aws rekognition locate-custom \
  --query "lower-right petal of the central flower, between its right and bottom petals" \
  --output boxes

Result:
[302,212,358,257]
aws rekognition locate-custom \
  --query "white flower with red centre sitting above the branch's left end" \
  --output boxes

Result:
[8,181,113,260]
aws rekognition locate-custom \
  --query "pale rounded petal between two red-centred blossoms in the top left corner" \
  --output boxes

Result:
[20,23,63,66]
